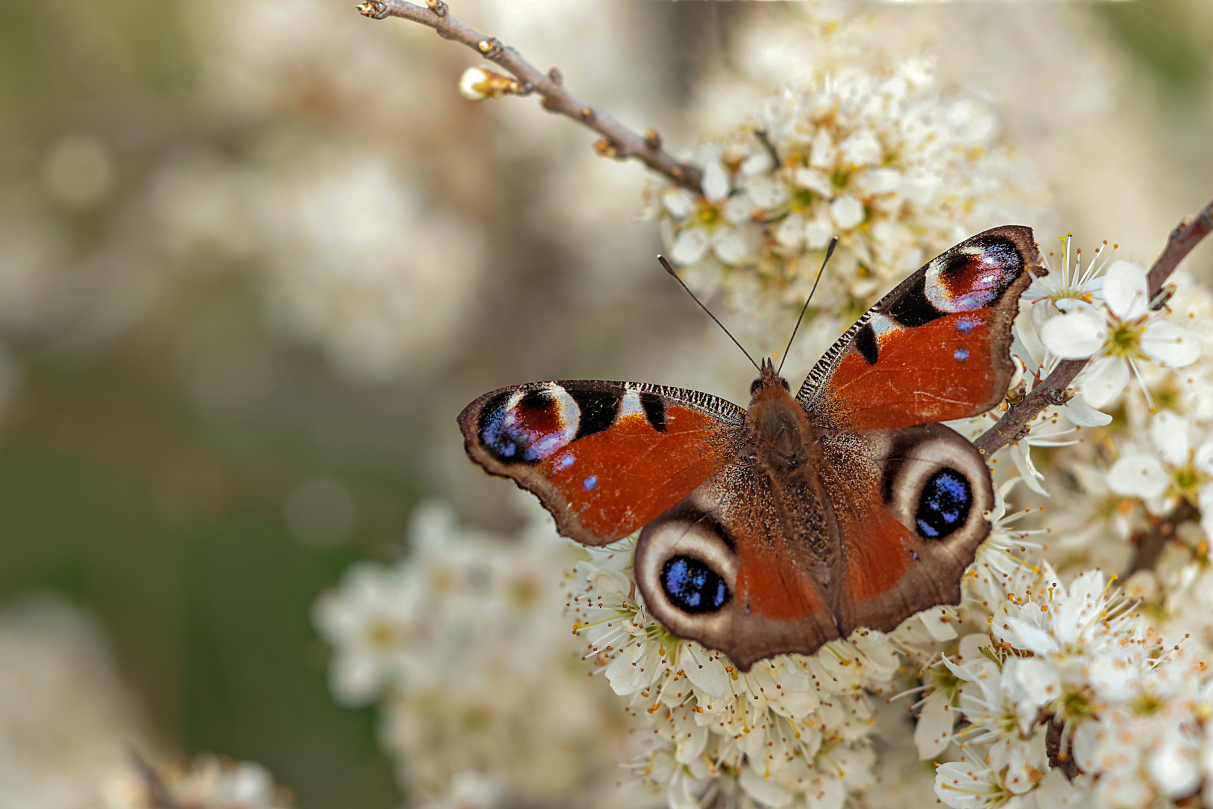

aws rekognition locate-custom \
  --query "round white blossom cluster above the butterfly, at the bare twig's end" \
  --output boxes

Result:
[654,69,1029,312]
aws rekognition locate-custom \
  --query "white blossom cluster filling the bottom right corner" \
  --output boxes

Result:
[935,565,1213,809]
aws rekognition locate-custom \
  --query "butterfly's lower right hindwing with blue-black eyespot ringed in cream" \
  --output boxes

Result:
[815,425,993,634]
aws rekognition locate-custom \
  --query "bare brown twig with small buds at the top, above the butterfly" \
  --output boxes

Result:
[358,0,702,193]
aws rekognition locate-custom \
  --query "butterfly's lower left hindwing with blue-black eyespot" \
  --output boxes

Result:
[636,462,839,671]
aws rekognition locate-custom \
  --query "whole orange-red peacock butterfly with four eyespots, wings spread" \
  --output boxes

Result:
[459,226,1044,671]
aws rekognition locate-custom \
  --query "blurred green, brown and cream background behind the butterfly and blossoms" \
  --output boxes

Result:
[0,0,1213,809]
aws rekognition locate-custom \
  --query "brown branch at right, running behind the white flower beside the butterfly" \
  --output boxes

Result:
[973,196,1213,457]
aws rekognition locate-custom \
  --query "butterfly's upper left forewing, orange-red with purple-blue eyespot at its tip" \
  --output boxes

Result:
[459,381,746,545]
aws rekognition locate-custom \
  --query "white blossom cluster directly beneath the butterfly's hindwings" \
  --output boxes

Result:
[569,542,899,809]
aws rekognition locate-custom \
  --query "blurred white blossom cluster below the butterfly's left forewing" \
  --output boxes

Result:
[315,506,625,805]
